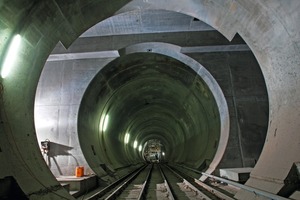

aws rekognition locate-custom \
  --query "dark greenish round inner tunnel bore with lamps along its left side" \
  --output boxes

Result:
[78,53,220,179]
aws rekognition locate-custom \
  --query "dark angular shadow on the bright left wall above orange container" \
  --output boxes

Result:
[44,141,79,175]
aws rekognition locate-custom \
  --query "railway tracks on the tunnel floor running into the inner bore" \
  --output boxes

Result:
[79,164,233,200]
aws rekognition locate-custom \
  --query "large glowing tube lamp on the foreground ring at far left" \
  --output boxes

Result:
[1,34,21,78]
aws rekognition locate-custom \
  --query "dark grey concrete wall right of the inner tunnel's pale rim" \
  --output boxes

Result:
[189,52,269,168]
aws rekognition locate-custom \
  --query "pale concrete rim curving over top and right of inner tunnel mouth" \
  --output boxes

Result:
[119,42,229,181]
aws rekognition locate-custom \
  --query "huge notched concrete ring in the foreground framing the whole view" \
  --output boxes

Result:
[0,0,300,199]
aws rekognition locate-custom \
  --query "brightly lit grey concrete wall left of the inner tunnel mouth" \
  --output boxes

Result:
[35,59,111,177]
